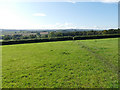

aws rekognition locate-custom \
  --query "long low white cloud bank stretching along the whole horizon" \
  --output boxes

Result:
[0,22,117,30]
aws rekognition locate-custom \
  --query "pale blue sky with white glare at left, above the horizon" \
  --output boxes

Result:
[0,0,118,29]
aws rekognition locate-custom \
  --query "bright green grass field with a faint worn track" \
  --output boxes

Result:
[2,38,118,88]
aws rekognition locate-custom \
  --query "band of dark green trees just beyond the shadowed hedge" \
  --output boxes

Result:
[1,28,120,40]
